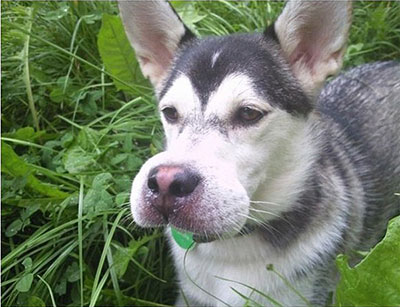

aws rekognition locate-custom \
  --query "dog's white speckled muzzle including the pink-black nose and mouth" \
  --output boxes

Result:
[130,152,249,240]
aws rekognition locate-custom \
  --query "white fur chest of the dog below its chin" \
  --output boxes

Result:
[171,233,313,306]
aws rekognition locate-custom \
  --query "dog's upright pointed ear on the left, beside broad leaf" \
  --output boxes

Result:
[118,0,194,89]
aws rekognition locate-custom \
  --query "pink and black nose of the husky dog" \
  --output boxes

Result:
[147,166,200,197]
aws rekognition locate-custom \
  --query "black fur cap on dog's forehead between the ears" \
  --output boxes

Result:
[159,31,312,116]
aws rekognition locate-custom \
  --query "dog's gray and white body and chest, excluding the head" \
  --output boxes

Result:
[171,63,400,306]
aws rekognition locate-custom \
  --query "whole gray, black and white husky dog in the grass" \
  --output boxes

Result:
[119,1,400,306]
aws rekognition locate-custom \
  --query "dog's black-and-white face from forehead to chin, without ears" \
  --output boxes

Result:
[131,35,311,236]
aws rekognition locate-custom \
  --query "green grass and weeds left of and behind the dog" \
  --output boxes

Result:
[1,1,400,306]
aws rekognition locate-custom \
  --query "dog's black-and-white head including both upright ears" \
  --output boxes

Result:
[119,1,350,241]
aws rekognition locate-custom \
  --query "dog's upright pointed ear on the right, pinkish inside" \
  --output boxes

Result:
[275,0,351,97]
